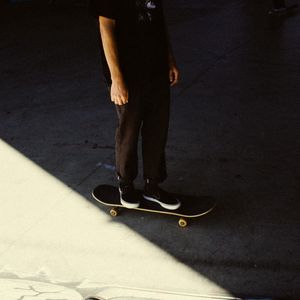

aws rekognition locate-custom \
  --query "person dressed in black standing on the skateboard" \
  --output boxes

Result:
[90,0,180,210]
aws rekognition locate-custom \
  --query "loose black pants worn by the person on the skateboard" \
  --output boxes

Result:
[115,79,170,183]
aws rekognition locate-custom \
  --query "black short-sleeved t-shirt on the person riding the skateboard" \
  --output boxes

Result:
[90,0,168,83]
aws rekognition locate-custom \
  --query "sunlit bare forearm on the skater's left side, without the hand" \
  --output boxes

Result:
[99,17,123,81]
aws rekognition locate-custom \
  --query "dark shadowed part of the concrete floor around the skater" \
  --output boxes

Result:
[0,0,300,299]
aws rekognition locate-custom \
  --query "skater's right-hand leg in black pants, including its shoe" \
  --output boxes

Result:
[142,81,180,210]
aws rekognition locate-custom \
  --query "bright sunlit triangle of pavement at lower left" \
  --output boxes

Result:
[0,142,234,300]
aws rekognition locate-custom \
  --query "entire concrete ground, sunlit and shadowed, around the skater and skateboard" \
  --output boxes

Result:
[0,0,300,300]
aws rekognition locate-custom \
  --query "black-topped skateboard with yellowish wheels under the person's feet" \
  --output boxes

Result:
[92,185,216,228]
